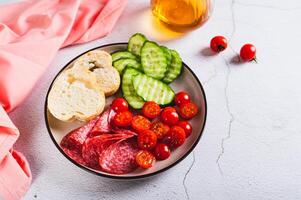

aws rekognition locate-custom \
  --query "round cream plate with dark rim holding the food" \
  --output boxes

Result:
[45,43,207,179]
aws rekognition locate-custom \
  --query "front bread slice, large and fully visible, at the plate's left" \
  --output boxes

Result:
[47,68,105,121]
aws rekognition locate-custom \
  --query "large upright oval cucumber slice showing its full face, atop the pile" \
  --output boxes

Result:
[141,41,167,79]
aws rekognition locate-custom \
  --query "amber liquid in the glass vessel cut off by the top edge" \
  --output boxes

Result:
[151,0,210,26]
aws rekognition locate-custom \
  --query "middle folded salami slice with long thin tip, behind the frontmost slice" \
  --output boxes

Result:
[82,134,132,169]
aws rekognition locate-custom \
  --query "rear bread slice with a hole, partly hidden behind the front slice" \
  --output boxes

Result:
[73,50,120,96]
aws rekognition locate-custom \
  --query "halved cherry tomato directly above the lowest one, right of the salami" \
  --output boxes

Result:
[138,130,157,150]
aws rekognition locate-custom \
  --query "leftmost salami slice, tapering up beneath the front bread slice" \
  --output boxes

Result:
[61,117,99,150]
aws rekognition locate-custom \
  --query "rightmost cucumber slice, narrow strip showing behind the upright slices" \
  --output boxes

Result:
[162,50,183,83]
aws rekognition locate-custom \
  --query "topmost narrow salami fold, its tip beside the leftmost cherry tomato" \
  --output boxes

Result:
[89,109,110,137]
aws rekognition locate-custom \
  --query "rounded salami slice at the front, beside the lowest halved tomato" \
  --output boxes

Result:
[99,139,138,174]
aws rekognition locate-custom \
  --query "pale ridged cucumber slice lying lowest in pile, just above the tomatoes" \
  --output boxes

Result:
[133,74,175,105]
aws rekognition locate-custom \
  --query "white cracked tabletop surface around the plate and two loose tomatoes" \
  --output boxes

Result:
[4,0,301,200]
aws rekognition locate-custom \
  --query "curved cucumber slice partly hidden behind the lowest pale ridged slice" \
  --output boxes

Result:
[121,67,144,109]
